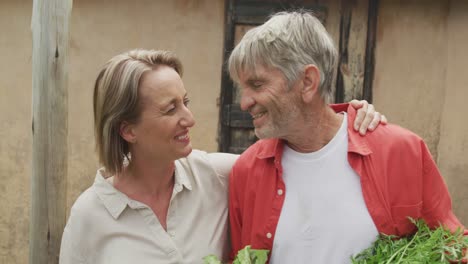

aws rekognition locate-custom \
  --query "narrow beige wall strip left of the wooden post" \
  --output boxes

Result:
[0,0,32,263]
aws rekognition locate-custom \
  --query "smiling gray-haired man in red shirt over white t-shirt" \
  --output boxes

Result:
[229,12,468,263]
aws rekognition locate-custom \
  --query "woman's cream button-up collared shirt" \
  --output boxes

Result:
[60,150,238,264]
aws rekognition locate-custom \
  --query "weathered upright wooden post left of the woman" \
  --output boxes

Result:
[29,0,72,264]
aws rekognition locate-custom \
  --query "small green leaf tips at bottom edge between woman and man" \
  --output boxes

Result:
[203,246,269,264]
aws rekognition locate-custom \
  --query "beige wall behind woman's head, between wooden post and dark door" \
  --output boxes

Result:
[67,0,224,216]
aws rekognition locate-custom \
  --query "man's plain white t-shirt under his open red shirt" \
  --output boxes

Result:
[271,116,378,264]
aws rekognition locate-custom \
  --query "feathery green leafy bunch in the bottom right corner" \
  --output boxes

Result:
[351,219,468,264]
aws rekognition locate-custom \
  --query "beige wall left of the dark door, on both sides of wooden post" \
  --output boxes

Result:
[0,0,224,263]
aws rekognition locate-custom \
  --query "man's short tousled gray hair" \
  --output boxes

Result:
[228,11,338,100]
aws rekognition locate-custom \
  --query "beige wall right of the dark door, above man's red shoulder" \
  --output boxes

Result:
[373,0,468,225]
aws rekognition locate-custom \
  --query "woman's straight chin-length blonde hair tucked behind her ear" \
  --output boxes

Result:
[93,49,183,175]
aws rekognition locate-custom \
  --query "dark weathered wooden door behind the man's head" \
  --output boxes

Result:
[218,0,377,153]
